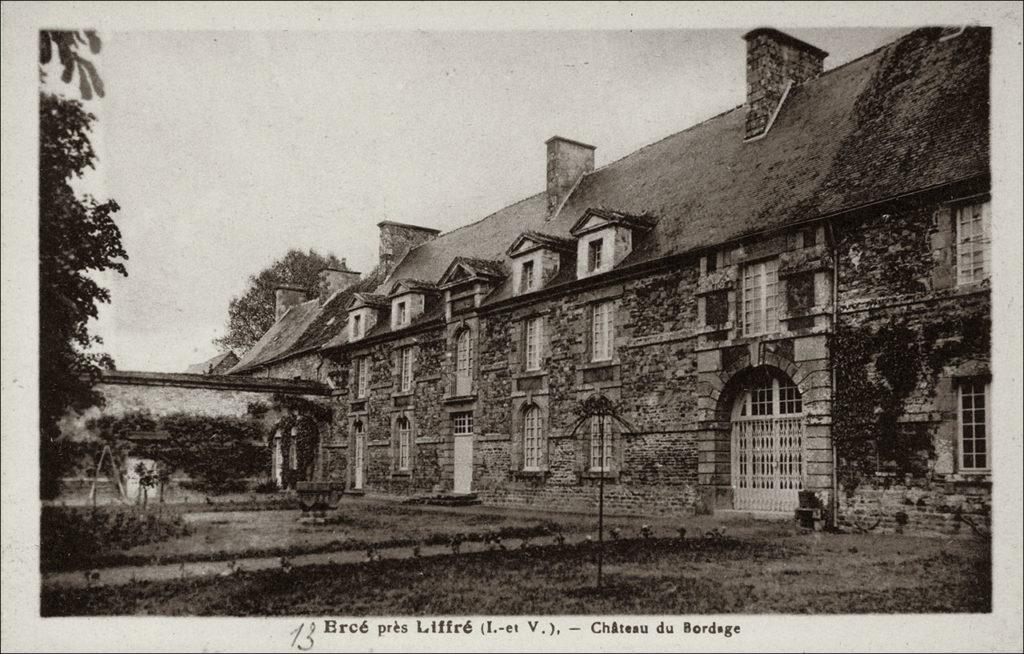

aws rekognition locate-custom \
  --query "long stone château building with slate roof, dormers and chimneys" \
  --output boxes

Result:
[224,28,998,530]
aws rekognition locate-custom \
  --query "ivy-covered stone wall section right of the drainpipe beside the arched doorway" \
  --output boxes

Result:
[837,205,998,532]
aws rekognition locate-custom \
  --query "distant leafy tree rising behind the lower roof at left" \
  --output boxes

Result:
[213,249,343,351]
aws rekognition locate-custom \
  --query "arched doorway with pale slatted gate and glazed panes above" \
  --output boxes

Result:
[731,366,804,512]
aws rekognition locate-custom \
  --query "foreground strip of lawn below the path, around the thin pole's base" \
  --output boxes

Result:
[42,534,991,616]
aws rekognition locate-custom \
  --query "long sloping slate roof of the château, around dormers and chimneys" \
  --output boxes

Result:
[236,28,991,370]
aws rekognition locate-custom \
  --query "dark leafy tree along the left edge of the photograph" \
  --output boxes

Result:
[39,32,128,497]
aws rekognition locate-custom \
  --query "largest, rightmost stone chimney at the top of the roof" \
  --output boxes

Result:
[743,28,828,139]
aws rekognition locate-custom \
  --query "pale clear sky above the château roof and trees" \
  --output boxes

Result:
[50,26,909,372]
